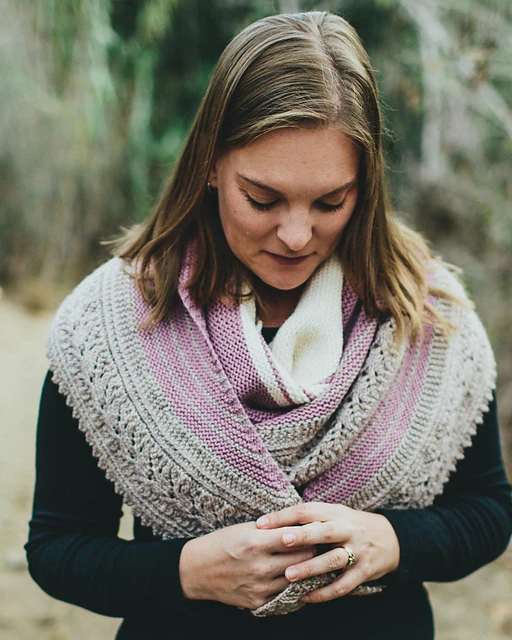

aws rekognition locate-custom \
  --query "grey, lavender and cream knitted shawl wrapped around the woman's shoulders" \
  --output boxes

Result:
[48,258,495,616]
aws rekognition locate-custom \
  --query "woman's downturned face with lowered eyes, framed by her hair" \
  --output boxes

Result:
[209,127,360,290]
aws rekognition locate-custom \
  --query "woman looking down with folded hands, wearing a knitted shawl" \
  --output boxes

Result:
[27,12,512,640]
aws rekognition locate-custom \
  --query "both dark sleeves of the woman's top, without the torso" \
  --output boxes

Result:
[26,375,512,617]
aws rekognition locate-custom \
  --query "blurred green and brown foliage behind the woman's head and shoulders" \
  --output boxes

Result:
[0,0,512,438]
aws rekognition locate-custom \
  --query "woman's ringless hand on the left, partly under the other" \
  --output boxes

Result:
[179,522,316,609]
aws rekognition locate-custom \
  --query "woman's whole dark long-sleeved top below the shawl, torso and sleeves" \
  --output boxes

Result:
[26,364,512,640]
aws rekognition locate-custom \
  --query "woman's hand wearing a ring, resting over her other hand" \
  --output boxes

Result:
[256,502,400,602]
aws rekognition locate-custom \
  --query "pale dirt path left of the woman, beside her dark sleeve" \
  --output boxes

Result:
[0,300,119,640]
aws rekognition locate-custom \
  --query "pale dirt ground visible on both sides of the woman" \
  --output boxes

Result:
[0,299,512,640]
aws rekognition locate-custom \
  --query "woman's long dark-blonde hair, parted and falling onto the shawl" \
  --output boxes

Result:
[119,11,456,338]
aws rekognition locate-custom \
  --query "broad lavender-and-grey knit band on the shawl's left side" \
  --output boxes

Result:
[136,293,287,490]
